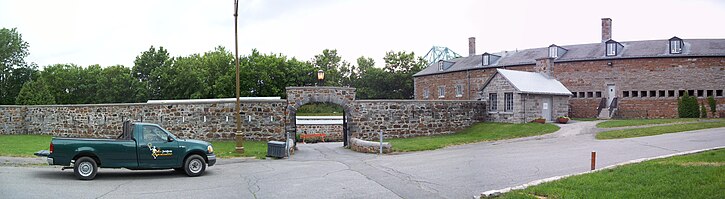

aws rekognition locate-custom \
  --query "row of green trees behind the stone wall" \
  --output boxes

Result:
[0,28,426,105]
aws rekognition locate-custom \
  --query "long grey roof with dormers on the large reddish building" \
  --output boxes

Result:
[413,39,725,77]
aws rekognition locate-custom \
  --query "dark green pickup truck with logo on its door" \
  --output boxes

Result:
[36,122,216,180]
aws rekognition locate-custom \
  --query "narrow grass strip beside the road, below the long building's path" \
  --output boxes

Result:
[596,120,725,139]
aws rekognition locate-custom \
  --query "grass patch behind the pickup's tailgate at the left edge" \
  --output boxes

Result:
[0,135,52,157]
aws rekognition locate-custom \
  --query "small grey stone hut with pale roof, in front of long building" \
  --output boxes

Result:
[480,69,572,123]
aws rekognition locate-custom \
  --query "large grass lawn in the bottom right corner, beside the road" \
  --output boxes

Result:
[500,149,725,198]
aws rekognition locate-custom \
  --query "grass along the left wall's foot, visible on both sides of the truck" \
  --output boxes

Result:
[0,135,267,159]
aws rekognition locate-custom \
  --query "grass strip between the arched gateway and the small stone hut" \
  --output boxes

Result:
[387,122,559,152]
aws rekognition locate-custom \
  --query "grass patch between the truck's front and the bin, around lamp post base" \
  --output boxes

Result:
[211,140,267,159]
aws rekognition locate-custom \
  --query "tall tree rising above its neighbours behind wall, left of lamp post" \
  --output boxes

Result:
[132,46,172,99]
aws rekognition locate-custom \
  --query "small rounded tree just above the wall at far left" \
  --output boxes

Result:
[15,79,55,105]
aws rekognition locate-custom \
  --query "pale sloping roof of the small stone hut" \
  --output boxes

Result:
[482,69,571,95]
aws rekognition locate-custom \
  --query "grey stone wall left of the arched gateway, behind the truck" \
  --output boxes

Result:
[0,100,286,140]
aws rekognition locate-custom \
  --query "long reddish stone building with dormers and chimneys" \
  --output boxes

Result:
[414,18,725,118]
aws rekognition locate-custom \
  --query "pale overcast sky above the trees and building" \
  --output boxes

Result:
[0,0,725,67]
